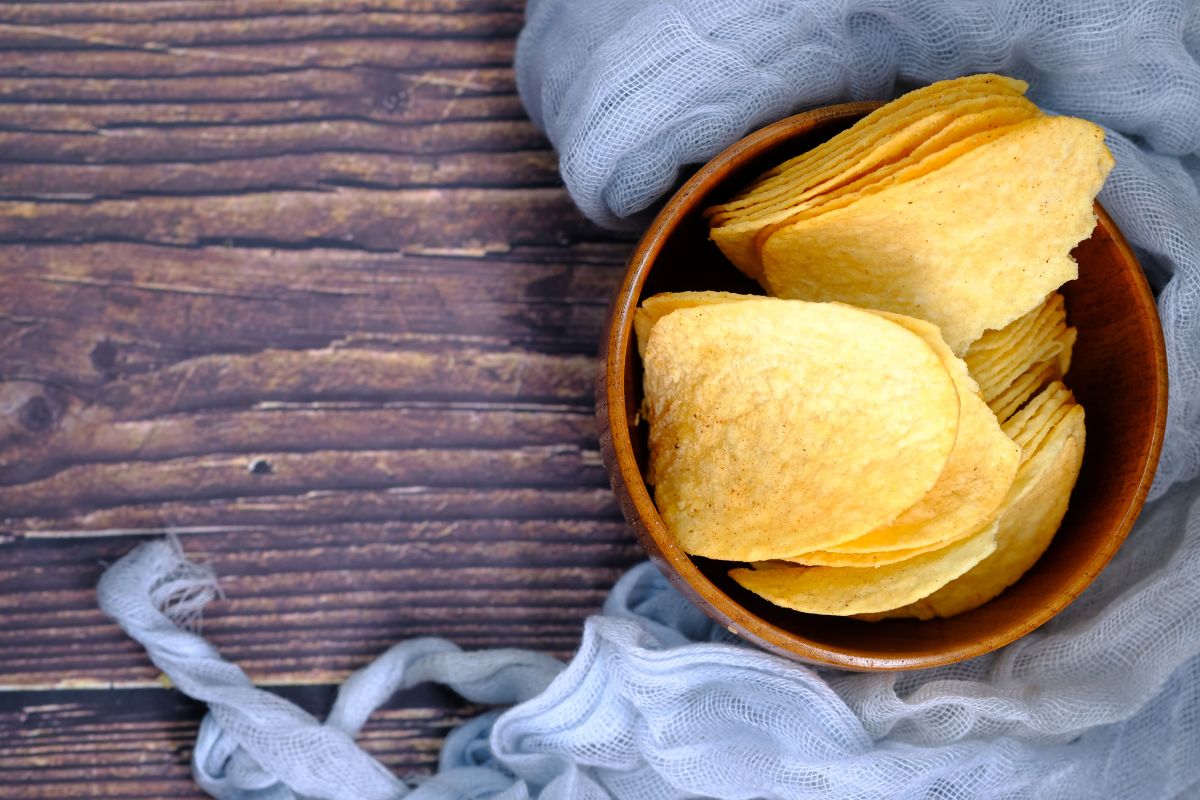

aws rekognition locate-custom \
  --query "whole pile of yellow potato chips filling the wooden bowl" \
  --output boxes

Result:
[635,76,1112,619]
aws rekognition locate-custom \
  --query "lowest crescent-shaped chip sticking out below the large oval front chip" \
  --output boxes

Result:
[730,524,997,615]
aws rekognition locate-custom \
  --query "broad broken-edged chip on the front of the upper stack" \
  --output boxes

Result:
[762,116,1112,353]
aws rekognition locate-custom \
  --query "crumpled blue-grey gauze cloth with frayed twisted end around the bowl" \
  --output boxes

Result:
[98,0,1200,800]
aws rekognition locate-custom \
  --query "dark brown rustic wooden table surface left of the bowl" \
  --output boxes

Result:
[0,0,641,798]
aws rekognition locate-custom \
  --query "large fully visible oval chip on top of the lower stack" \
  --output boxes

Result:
[644,297,959,561]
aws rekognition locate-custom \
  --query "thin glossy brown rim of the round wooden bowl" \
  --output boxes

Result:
[596,101,1168,672]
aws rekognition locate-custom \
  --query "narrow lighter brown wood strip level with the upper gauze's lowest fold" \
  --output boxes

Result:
[0,187,593,252]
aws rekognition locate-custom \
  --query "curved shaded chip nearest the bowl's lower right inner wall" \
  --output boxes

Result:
[870,405,1086,619]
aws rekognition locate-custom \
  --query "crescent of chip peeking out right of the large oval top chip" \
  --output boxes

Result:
[827,312,1021,554]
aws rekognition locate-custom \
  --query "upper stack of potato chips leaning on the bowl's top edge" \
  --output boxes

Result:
[707,76,1112,355]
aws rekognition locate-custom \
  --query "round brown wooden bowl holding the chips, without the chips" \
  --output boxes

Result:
[596,103,1166,670]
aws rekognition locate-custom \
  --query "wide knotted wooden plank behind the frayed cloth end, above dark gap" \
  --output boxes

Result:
[0,242,640,687]
